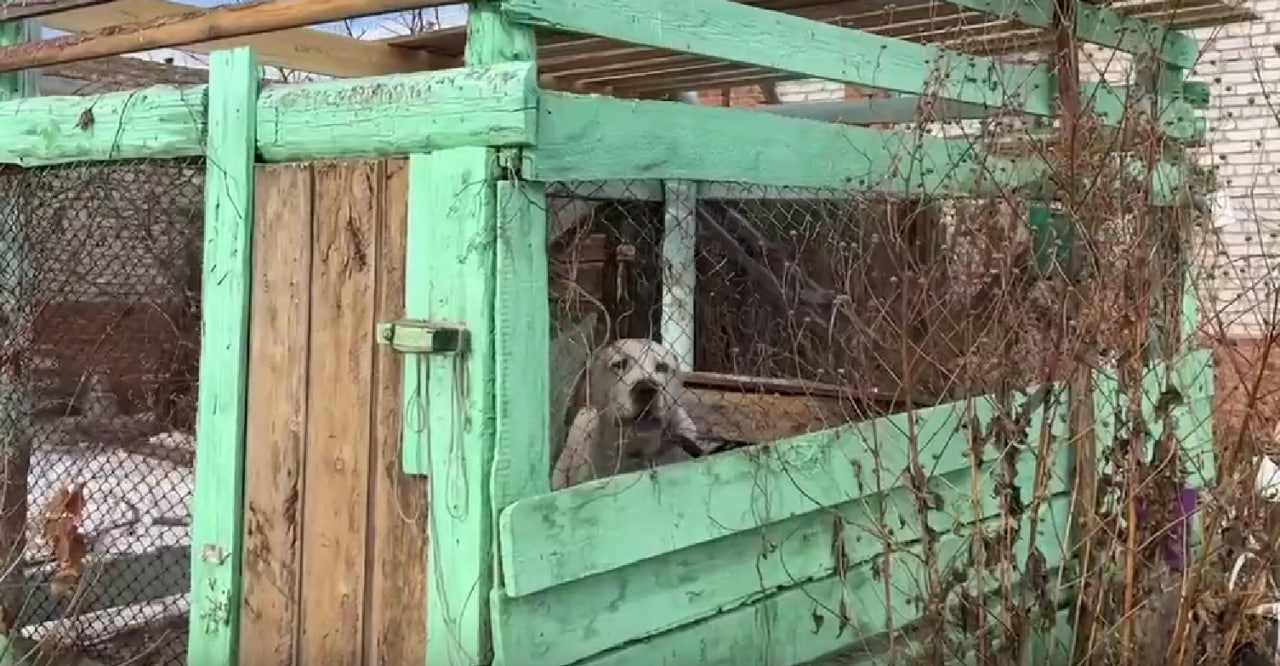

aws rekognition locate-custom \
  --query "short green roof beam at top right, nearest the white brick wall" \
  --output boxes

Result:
[947,0,1199,68]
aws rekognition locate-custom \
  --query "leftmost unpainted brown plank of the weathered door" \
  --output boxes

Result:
[239,165,314,665]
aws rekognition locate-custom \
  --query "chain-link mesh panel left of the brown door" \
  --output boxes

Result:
[0,159,204,663]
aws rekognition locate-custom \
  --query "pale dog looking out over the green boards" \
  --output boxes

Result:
[552,338,701,491]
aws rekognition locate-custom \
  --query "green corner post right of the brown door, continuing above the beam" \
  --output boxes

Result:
[403,3,550,666]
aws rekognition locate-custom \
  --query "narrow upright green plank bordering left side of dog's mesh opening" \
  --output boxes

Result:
[492,181,552,517]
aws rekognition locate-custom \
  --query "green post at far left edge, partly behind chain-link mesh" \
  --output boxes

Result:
[0,15,38,663]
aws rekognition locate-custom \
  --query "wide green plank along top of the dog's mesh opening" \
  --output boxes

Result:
[522,91,1183,205]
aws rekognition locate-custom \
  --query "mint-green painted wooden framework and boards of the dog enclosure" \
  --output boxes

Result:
[0,0,1212,666]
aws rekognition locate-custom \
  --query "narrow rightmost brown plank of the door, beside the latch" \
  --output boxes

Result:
[365,160,428,665]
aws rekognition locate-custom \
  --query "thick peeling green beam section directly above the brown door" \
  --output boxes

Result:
[257,63,538,161]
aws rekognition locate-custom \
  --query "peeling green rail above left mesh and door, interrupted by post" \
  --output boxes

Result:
[0,63,538,167]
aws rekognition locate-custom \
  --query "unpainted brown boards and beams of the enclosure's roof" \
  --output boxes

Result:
[0,0,1257,97]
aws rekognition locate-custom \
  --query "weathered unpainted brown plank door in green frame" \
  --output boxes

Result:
[239,160,426,666]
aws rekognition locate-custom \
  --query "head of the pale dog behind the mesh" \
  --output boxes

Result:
[588,338,684,430]
